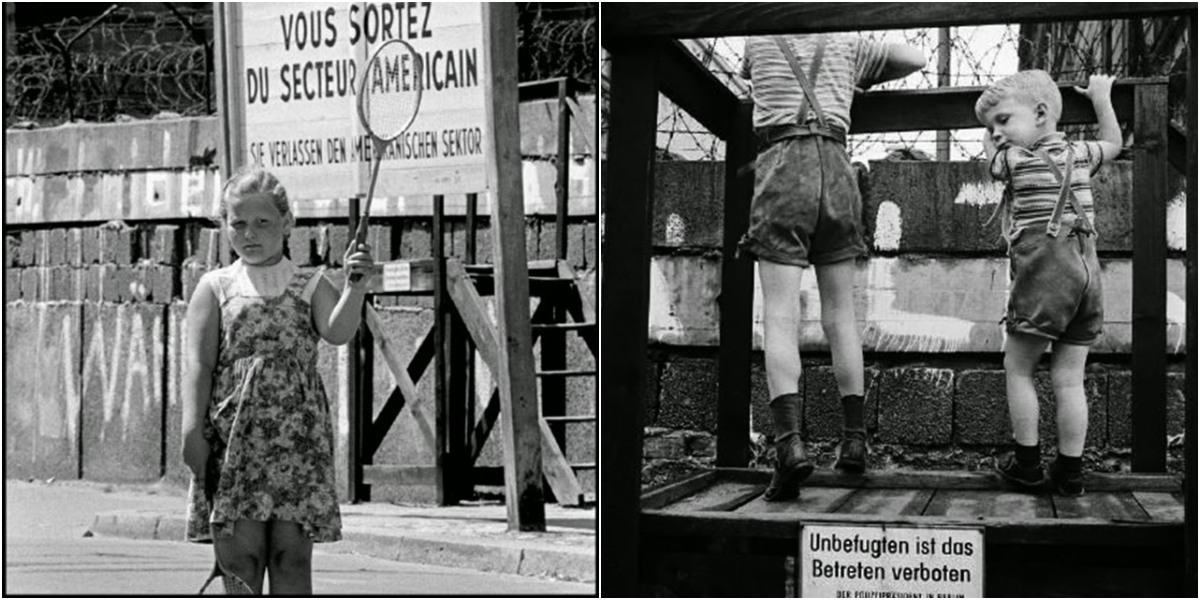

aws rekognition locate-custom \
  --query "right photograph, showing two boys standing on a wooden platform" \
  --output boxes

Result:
[600,2,1196,598]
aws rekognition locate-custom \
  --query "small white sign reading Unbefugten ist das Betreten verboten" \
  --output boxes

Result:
[798,523,983,598]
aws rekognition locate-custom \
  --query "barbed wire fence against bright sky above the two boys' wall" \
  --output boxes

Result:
[600,19,1187,160]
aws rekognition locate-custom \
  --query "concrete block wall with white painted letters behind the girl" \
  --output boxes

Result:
[4,102,598,502]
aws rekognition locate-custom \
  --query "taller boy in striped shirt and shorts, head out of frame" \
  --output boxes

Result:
[739,34,925,500]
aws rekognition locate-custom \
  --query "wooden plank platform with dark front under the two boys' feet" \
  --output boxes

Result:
[640,469,1184,596]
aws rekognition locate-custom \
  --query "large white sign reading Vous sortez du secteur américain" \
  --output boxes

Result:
[226,2,487,202]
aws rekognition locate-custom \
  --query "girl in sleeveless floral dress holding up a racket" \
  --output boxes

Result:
[182,170,373,595]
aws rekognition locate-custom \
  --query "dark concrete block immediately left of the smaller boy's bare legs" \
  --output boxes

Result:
[954,370,1013,445]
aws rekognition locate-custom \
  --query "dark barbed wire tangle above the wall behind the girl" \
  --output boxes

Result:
[4,2,599,128]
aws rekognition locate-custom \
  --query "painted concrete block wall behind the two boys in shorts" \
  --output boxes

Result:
[644,161,1193,461]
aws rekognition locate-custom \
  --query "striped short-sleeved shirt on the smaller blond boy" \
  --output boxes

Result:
[991,132,1104,235]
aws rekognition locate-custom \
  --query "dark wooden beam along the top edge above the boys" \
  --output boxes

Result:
[600,2,1196,39]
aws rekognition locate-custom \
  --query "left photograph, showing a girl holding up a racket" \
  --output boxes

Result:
[4,2,600,598]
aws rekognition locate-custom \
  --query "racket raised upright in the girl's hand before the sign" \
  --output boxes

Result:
[350,40,424,281]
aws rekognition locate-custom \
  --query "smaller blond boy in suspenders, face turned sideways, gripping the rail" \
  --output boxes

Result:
[976,71,1122,496]
